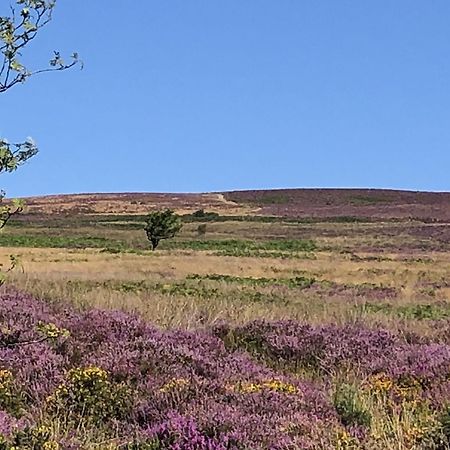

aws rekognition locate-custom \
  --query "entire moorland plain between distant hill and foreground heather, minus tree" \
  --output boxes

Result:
[5,197,450,331]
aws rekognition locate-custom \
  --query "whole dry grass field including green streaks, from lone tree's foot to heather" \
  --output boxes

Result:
[0,234,450,332]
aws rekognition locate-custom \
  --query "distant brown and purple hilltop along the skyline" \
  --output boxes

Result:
[21,189,450,221]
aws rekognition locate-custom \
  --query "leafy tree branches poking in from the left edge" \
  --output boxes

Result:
[0,0,82,228]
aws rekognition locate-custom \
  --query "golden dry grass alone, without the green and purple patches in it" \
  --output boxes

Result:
[6,243,450,334]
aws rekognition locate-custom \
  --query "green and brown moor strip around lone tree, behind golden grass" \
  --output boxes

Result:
[5,209,450,255]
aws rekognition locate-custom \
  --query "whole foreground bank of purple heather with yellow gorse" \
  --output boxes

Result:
[0,290,450,450]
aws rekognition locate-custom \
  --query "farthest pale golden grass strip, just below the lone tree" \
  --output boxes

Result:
[0,244,444,289]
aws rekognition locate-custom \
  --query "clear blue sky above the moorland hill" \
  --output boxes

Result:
[0,0,450,196]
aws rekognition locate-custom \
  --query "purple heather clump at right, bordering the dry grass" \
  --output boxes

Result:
[213,321,450,385]
